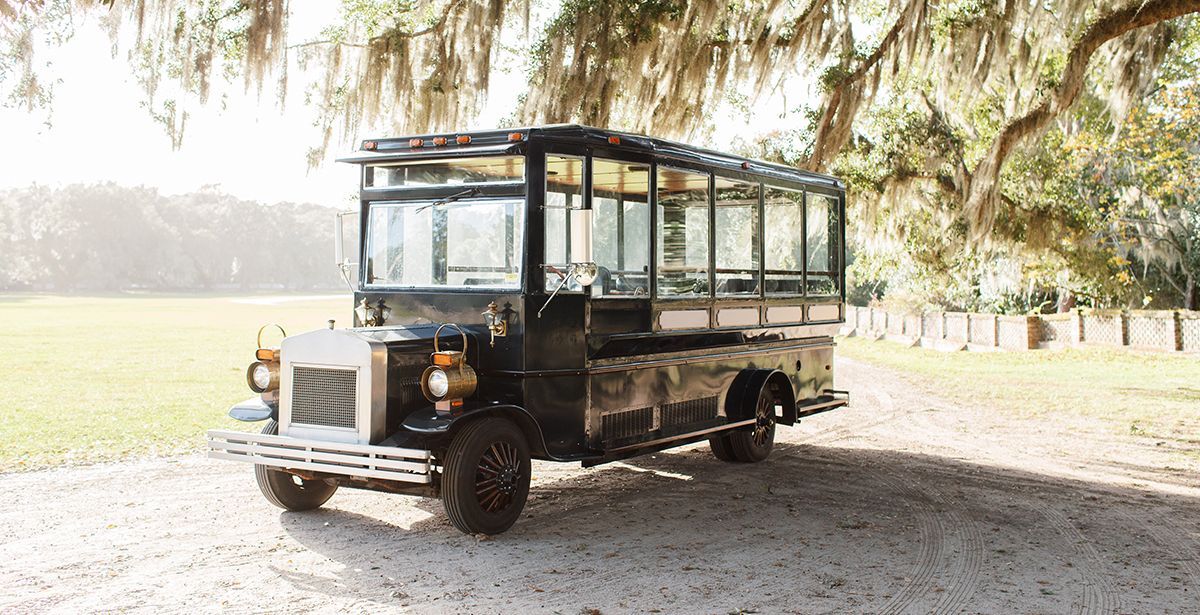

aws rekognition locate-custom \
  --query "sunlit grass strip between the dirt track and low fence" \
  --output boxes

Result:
[838,338,1200,440]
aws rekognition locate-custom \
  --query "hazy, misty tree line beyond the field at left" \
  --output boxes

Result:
[0,184,350,292]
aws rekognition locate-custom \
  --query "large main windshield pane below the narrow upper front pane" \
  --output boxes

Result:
[366,198,524,289]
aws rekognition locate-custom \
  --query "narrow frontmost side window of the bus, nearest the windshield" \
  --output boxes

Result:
[542,155,583,292]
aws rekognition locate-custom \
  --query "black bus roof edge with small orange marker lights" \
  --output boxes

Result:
[338,124,846,190]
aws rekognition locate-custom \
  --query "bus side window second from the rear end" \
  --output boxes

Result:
[763,186,804,297]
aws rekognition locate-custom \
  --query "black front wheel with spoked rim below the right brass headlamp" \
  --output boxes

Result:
[442,418,532,535]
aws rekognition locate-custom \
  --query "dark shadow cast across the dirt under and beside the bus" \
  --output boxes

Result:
[277,444,1200,613]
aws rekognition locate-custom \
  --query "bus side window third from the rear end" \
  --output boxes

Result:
[715,177,761,297]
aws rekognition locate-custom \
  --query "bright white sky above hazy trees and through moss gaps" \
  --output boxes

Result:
[0,2,797,207]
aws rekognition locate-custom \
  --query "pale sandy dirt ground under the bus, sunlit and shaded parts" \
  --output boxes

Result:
[0,360,1200,614]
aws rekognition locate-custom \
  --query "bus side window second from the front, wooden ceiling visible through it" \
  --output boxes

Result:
[592,159,650,297]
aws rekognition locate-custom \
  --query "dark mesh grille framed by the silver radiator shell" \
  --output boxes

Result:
[292,365,359,429]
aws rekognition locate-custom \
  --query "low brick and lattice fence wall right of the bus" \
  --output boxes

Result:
[844,305,1200,352]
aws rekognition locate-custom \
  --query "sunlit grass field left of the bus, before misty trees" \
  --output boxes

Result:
[0,295,352,472]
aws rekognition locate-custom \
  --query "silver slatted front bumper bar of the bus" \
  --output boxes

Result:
[208,430,432,484]
